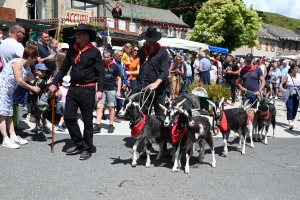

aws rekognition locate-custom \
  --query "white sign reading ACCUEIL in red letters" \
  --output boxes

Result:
[65,8,90,25]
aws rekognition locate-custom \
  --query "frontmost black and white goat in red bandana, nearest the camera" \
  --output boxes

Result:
[163,103,216,173]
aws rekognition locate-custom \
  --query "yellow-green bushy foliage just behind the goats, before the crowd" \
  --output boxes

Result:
[203,84,231,101]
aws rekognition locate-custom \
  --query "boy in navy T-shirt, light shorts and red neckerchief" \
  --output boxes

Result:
[93,50,121,133]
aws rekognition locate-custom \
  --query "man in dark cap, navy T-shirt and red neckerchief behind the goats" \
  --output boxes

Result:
[238,53,265,108]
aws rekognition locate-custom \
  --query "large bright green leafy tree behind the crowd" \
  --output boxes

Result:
[188,0,262,51]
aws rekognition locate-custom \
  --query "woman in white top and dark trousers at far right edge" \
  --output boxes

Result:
[279,64,300,130]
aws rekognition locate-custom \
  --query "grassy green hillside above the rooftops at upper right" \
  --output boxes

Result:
[263,12,300,32]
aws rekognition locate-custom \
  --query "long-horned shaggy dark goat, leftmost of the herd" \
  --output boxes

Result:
[119,92,168,168]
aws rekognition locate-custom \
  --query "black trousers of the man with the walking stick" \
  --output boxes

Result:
[64,86,96,152]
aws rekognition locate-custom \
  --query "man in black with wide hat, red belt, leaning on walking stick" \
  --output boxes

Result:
[49,24,104,160]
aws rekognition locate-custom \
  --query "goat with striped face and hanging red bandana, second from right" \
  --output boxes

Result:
[207,97,248,157]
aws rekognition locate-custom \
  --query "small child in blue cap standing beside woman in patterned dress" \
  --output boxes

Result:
[32,63,53,137]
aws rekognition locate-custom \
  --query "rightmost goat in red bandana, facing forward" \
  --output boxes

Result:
[254,93,276,145]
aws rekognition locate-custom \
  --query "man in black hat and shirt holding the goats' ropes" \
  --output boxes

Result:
[135,28,170,158]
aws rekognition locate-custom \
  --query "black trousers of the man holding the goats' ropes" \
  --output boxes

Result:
[140,88,166,116]
